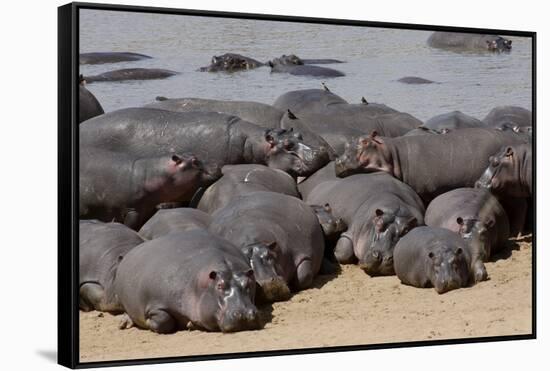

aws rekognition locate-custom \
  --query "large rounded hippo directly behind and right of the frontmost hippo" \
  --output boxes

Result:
[209,191,325,301]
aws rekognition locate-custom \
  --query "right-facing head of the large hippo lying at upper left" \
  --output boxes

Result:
[265,128,329,177]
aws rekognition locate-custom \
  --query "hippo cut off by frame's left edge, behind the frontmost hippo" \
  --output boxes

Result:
[78,220,143,313]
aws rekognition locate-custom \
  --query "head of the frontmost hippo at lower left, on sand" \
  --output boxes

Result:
[206,269,260,332]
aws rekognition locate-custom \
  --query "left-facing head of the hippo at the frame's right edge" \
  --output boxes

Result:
[475,147,524,197]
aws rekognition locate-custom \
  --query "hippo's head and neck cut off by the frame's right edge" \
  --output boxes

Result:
[476,143,533,197]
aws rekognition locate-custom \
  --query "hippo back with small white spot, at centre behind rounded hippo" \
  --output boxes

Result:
[197,164,300,214]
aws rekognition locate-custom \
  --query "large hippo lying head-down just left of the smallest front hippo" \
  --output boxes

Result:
[306,173,424,276]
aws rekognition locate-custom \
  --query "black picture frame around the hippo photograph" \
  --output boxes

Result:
[57,2,537,368]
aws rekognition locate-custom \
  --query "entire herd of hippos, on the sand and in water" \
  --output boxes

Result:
[79,33,533,333]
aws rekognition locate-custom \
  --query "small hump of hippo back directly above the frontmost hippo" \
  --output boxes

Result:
[139,207,210,240]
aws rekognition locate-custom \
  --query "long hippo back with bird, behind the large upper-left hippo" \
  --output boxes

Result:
[145,97,335,158]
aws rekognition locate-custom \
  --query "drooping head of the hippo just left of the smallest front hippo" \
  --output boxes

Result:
[355,209,417,276]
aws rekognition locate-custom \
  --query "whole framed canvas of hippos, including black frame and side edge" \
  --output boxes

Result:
[58,3,537,368]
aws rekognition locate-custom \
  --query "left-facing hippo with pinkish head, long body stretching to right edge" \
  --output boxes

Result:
[335,128,525,204]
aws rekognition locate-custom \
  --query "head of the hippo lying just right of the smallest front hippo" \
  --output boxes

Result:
[456,217,494,282]
